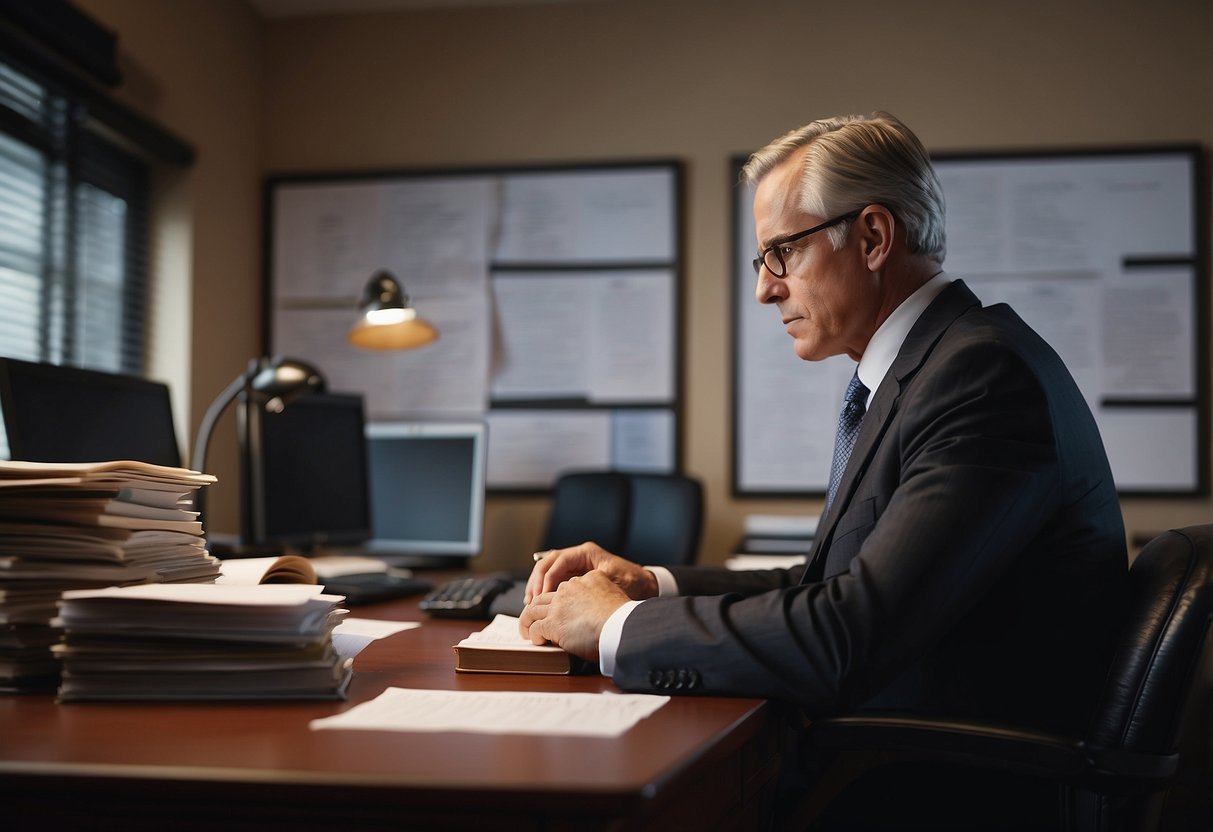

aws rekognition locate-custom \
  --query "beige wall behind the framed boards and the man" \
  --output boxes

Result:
[70,0,1213,566]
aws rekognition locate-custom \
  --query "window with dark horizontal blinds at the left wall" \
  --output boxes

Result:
[0,63,148,375]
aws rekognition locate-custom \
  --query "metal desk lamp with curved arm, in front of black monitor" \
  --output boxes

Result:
[190,355,325,553]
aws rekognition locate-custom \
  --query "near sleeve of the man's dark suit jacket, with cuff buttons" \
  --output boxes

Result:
[614,338,1058,714]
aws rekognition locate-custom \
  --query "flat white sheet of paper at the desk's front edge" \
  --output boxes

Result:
[309,688,670,737]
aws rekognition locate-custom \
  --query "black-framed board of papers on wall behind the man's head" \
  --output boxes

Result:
[733,146,1209,496]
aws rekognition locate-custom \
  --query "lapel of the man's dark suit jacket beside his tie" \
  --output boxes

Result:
[802,280,981,582]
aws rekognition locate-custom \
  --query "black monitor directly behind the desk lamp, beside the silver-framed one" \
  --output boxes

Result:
[250,393,370,549]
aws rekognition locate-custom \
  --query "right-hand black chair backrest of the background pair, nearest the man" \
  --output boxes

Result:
[620,474,704,566]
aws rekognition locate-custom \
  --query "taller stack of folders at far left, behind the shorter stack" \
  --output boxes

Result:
[0,461,220,691]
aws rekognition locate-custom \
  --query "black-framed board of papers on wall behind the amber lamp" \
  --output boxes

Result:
[264,161,682,491]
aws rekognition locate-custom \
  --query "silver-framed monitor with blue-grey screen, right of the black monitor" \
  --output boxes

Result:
[366,422,488,565]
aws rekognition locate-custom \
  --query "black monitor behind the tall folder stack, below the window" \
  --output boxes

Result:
[0,358,181,466]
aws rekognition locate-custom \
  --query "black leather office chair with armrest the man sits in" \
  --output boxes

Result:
[795,524,1213,832]
